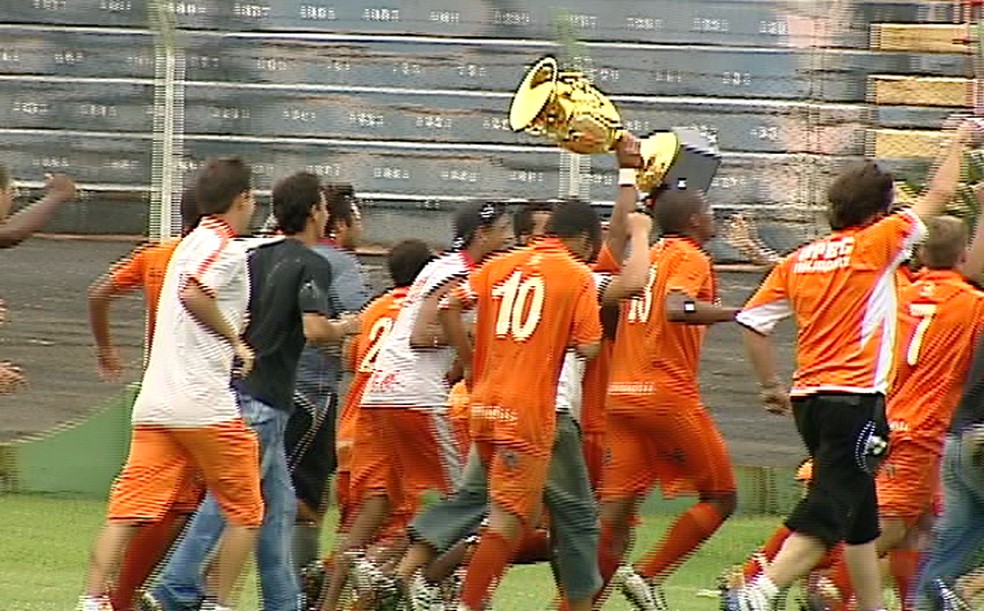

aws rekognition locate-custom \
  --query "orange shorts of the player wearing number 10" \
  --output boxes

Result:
[474,441,550,526]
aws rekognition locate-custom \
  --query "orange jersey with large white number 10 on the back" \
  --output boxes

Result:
[455,238,601,454]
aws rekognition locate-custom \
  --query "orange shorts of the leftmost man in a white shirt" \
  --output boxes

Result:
[109,418,263,526]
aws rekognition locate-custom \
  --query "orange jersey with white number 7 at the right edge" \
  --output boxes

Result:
[887,270,984,443]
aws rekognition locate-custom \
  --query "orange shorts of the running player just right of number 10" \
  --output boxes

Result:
[599,398,735,500]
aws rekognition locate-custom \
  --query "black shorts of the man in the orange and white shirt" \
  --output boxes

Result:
[786,393,889,547]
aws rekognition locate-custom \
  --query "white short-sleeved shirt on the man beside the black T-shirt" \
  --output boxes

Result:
[133,217,249,427]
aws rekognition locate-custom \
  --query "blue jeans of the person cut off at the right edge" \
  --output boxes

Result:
[917,435,984,609]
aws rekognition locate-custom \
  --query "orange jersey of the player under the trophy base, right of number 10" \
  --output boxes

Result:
[608,237,717,409]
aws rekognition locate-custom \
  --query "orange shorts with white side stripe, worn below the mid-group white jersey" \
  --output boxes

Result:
[350,408,461,513]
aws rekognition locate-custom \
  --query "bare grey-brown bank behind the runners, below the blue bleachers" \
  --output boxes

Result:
[0,238,803,466]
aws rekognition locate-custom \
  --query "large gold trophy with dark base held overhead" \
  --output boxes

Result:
[509,56,721,192]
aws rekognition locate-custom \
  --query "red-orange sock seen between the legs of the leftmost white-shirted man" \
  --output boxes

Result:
[112,511,188,611]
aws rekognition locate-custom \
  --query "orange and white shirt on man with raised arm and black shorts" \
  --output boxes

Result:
[738,210,926,397]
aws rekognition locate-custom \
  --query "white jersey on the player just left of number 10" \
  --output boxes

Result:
[362,251,473,409]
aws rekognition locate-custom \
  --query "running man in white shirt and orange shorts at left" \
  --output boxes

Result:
[80,159,263,611]
